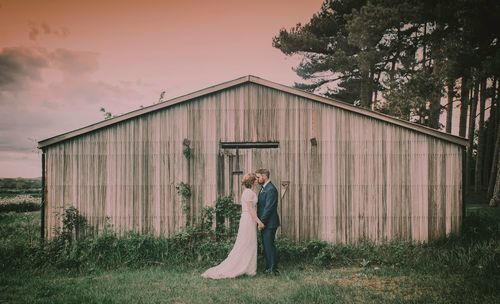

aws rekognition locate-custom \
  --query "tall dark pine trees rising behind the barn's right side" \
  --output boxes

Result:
[273,0,500,204]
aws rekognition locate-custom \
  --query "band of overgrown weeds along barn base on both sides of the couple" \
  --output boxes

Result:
[0,206,500,276]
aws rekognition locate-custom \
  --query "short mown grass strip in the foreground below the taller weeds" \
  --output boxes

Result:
[0,267,498,303]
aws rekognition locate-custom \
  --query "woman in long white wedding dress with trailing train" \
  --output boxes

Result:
[201,173,264,279]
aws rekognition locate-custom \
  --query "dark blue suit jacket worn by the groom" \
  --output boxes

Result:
[257,182,280,229]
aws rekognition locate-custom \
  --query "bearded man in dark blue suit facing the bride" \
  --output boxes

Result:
[255,169,280,274]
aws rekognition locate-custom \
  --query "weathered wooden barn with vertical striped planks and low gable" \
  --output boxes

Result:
[38,76,467,243]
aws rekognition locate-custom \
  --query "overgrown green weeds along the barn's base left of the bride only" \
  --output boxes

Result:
[31,228,232,270]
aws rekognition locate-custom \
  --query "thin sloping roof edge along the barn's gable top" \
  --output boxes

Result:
[38,75,467,149]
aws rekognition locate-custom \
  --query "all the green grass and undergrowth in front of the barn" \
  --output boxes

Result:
[0,212,500,303]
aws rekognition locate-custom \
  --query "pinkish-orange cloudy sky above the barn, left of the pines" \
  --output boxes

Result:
[0,0,323,177]
